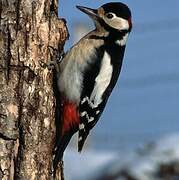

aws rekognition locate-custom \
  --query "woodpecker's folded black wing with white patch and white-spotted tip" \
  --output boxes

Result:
[78,45,125,151]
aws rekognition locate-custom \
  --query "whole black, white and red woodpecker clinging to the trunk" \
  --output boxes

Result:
[54,2,132,168]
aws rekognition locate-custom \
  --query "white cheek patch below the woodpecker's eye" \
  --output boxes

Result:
[104,14,129,30]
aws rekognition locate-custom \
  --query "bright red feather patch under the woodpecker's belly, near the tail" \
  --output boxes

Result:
[62,102,80,134]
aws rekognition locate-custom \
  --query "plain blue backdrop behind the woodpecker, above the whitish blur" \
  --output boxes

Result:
[59,0,179,149]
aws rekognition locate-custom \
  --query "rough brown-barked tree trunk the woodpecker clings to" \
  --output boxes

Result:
[0,0,68,180]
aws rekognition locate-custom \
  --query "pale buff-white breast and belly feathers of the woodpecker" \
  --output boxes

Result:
[58,39,103,103]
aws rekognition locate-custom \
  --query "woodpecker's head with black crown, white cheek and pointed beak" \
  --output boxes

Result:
[77,2,132,32]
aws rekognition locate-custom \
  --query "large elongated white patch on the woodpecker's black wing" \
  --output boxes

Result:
[90,52,113,107]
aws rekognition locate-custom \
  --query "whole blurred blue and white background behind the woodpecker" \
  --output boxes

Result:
[59,0,179,180]
